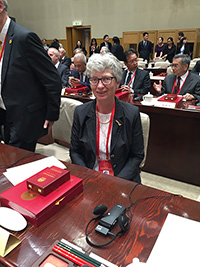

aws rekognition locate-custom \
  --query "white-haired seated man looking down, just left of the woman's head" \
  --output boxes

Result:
[68,53,90,89]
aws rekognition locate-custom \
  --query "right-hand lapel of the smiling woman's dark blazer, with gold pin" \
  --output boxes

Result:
[110,98,124,153]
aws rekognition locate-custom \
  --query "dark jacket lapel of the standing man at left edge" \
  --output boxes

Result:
[1,20,15,88]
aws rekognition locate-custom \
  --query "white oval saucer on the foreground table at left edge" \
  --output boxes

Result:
[0,207,27,231]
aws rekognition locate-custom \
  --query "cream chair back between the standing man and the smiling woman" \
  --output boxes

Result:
[52,97,83,144]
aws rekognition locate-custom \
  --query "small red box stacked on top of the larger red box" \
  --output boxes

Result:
[26,166,70,196]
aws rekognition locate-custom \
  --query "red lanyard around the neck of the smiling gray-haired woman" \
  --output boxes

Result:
[96,103,115,160]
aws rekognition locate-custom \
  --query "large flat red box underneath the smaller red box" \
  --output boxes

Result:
[0,175,83,226]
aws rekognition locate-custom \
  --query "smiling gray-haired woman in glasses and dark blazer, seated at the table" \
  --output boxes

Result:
[70,53,144,183]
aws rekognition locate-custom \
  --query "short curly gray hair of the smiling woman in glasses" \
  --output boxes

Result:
[87,53,122,82]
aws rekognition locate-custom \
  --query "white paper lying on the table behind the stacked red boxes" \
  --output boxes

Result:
[3,156,66,185]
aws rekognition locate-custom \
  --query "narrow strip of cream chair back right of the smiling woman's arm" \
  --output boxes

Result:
[140,112,150,168]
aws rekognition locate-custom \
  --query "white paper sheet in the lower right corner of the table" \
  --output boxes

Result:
[147,214,200,267]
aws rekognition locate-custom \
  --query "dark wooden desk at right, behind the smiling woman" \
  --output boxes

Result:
[132,98,200,185]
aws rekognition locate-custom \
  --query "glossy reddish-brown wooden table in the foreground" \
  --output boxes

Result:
[0,144,200,267]
